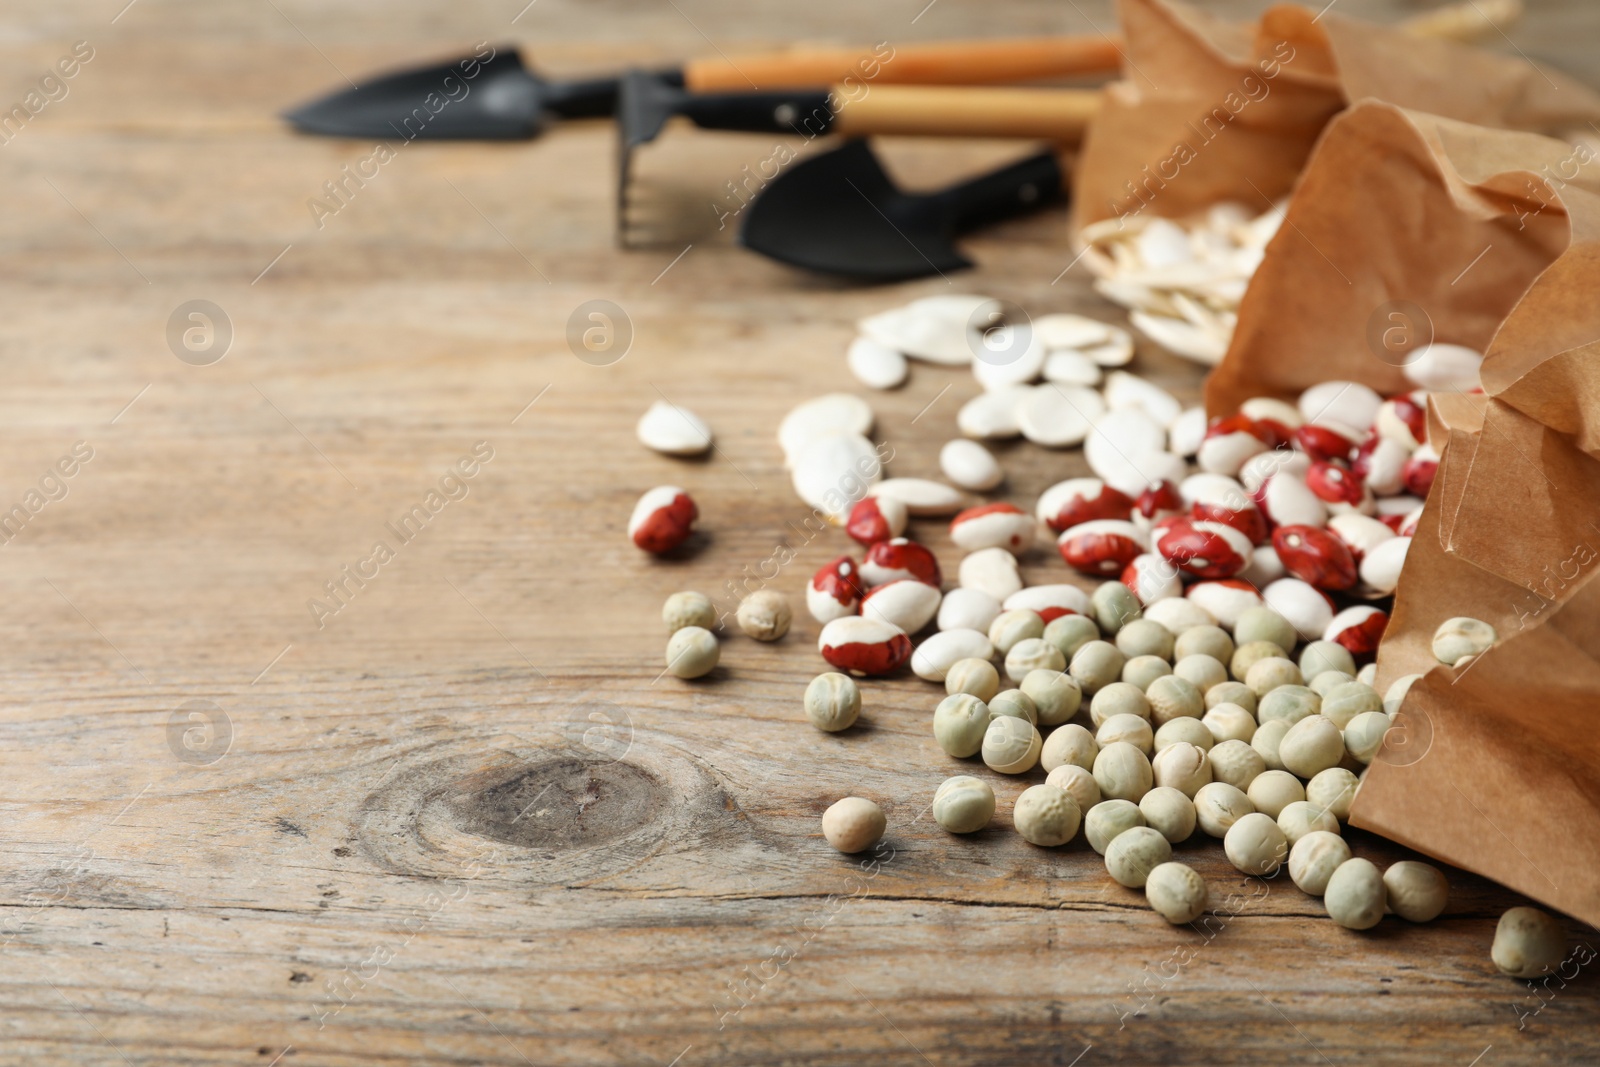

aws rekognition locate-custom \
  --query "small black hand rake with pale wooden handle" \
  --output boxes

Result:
[616,82,1101,246]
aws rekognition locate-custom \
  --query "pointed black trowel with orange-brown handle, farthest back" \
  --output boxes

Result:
[283,35,1122,141]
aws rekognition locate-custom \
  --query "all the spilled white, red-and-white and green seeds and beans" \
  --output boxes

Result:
[629,205,1562,976]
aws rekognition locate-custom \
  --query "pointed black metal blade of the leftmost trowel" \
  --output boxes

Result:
[283,46,643,141]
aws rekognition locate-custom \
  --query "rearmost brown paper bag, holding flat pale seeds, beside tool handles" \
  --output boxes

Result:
[1072,0,1600,234]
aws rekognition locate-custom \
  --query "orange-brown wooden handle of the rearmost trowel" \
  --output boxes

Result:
[683,34,1122,93]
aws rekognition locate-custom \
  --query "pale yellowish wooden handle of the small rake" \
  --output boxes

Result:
[834,85,1101,144]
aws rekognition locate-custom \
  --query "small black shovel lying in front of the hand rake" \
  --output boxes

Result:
[739,141,1066,282]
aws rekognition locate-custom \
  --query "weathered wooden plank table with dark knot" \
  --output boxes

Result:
[0,0,1600,1067]
